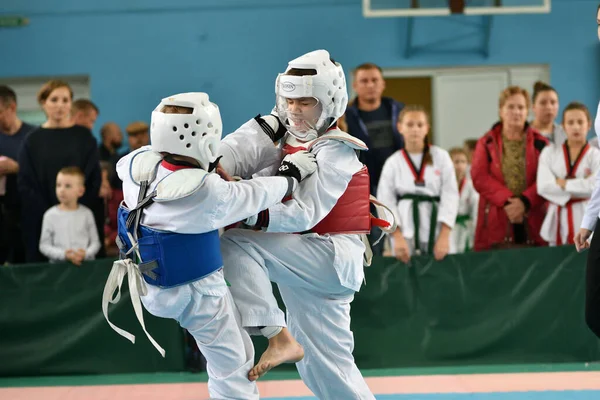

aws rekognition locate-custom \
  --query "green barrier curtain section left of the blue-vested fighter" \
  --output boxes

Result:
[0,260,184,376]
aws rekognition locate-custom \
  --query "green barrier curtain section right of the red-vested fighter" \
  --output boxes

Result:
[352,246,600,368]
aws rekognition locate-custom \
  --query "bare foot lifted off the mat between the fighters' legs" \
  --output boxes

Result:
[248,328,304,381]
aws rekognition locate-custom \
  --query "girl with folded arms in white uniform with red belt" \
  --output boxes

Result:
[537,103,600,246]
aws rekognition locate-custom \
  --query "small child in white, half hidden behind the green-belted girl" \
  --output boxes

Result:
[449,147,479,254]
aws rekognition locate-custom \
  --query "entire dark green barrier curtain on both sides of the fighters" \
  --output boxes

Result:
[0,247,600,376]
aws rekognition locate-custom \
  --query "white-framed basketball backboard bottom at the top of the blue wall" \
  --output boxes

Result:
[362,0,551,18]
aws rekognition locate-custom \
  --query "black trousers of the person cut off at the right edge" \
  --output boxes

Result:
[585,219,600,338]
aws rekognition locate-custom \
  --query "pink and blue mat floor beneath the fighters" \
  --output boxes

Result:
[0,364,600,400]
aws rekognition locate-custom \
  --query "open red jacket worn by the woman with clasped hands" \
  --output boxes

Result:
[471,123,548,251]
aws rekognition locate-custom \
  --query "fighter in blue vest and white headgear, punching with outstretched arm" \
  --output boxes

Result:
[102,93,316,399]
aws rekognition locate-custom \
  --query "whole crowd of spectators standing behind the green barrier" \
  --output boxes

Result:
[0,63,600,265]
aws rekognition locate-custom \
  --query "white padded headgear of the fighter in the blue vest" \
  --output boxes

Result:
[150,92,223,171]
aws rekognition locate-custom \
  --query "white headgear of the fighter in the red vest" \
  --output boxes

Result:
[275,50,348,141]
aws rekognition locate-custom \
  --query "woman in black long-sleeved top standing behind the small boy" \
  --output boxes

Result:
[18,79,104,262]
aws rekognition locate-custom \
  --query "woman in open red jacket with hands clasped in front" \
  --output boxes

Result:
[471,86,548,251]
